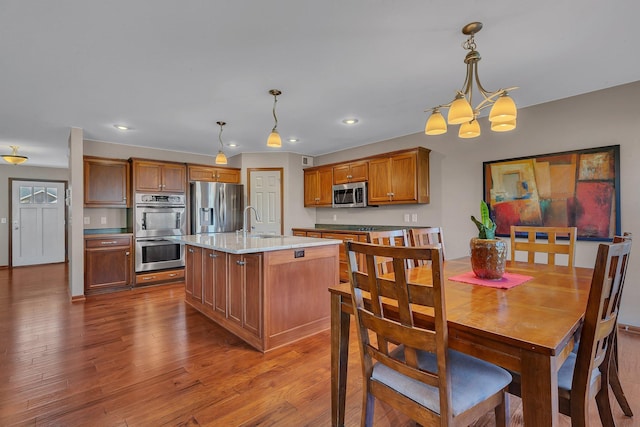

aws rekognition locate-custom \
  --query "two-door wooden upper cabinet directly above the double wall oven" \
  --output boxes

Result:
[133,159,187,193]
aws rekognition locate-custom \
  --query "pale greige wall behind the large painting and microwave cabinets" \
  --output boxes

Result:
[314,82,640,326]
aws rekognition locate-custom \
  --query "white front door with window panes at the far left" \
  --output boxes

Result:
[11,180,65,266]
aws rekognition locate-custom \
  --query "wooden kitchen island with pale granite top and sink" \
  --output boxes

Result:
[171,233,342,352]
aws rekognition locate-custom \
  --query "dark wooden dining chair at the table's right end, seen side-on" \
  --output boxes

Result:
[509,241,631,427]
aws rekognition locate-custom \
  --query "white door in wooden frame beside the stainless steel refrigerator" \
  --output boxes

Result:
[249,169,282,234]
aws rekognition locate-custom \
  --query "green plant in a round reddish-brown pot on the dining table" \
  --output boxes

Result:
[469,200,507,280]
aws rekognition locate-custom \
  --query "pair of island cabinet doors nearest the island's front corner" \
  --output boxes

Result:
[227,254,262,338]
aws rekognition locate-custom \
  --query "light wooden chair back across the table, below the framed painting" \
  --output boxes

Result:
[511,225,577,267]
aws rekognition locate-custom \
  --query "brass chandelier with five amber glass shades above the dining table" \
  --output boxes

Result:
[424,22,518,138]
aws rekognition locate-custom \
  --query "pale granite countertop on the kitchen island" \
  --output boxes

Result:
[165,233,342,254]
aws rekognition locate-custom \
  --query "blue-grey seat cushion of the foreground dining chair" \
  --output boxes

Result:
[371,346,511,417]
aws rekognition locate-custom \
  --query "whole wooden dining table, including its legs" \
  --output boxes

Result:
[329,257,593,427]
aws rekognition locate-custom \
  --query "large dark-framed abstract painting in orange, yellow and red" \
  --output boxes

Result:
[483,145,620,241]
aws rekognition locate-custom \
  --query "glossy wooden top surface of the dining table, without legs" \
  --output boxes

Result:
[329,257,593,356]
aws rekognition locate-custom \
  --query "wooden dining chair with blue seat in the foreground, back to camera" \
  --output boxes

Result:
[346,242,511,426]
